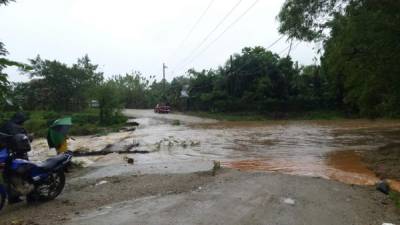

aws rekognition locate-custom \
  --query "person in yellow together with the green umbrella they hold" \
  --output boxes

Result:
[47,117,72,154]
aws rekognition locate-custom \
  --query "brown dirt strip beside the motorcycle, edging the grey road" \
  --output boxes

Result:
[0,172,219,225]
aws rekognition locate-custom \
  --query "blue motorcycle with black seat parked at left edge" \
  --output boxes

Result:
[0,133,72,210]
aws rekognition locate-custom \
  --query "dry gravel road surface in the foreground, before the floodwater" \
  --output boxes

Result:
[0,169,400,225]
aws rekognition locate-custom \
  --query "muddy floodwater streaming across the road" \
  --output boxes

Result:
[32,110,400,188]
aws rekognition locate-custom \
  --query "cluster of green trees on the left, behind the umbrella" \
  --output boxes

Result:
[3,56,126,131]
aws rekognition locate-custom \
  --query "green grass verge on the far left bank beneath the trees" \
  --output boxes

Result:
[0,109,127,137]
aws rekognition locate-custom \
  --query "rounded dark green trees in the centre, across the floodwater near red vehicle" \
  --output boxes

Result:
[181,47,328,114]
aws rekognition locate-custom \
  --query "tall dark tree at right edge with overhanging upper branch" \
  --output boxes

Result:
[279,0,400,117]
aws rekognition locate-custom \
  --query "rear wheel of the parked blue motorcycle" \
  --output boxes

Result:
[27,171,65,202]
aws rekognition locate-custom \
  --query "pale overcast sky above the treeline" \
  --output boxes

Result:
[0,0,315,81]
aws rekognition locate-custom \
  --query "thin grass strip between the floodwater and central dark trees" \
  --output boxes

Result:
[185,111,348,121]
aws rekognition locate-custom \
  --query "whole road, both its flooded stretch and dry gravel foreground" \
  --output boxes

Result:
[6,110,400,225]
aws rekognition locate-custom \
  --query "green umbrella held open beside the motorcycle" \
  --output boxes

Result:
[47,117,72,148]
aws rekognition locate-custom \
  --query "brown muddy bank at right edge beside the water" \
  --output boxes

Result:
[362,143,400,180]
